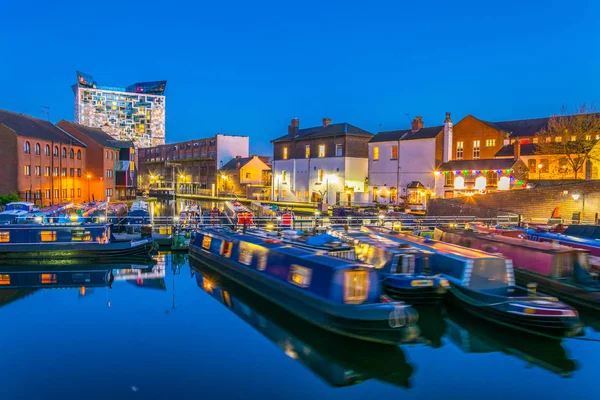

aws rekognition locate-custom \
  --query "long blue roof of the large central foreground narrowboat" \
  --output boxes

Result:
[198,228,368,270]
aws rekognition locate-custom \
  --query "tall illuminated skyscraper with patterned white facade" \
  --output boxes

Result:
[73,71,167,147]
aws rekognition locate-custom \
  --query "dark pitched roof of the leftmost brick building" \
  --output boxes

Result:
[0,110,85,147]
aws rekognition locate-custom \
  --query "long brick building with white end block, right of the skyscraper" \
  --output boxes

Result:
[138,134,249,194]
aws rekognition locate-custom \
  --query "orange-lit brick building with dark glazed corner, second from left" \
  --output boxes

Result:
[56,120,137,200]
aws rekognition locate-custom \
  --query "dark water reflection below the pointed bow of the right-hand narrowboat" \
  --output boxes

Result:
[447,309,576,376]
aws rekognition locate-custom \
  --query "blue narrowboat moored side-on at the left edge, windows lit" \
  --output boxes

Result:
[0,224,157,262]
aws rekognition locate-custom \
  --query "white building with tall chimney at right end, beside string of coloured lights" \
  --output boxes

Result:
[369,113,452,208]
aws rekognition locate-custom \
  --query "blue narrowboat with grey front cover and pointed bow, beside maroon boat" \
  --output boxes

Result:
[365,228,583,337]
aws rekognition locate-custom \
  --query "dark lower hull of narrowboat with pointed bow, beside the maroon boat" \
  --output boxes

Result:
[449,284,583,338]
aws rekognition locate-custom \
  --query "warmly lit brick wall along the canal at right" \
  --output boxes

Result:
[427,181,600,223]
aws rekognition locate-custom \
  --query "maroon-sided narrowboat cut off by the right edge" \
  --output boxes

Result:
[435,228,600,311]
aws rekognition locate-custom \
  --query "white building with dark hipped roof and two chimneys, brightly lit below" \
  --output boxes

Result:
[271,118,373,205]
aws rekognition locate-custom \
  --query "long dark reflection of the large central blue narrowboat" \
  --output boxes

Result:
[191,261,413,387]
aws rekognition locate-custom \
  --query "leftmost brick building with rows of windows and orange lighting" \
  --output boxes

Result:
[0,110,87,206]
